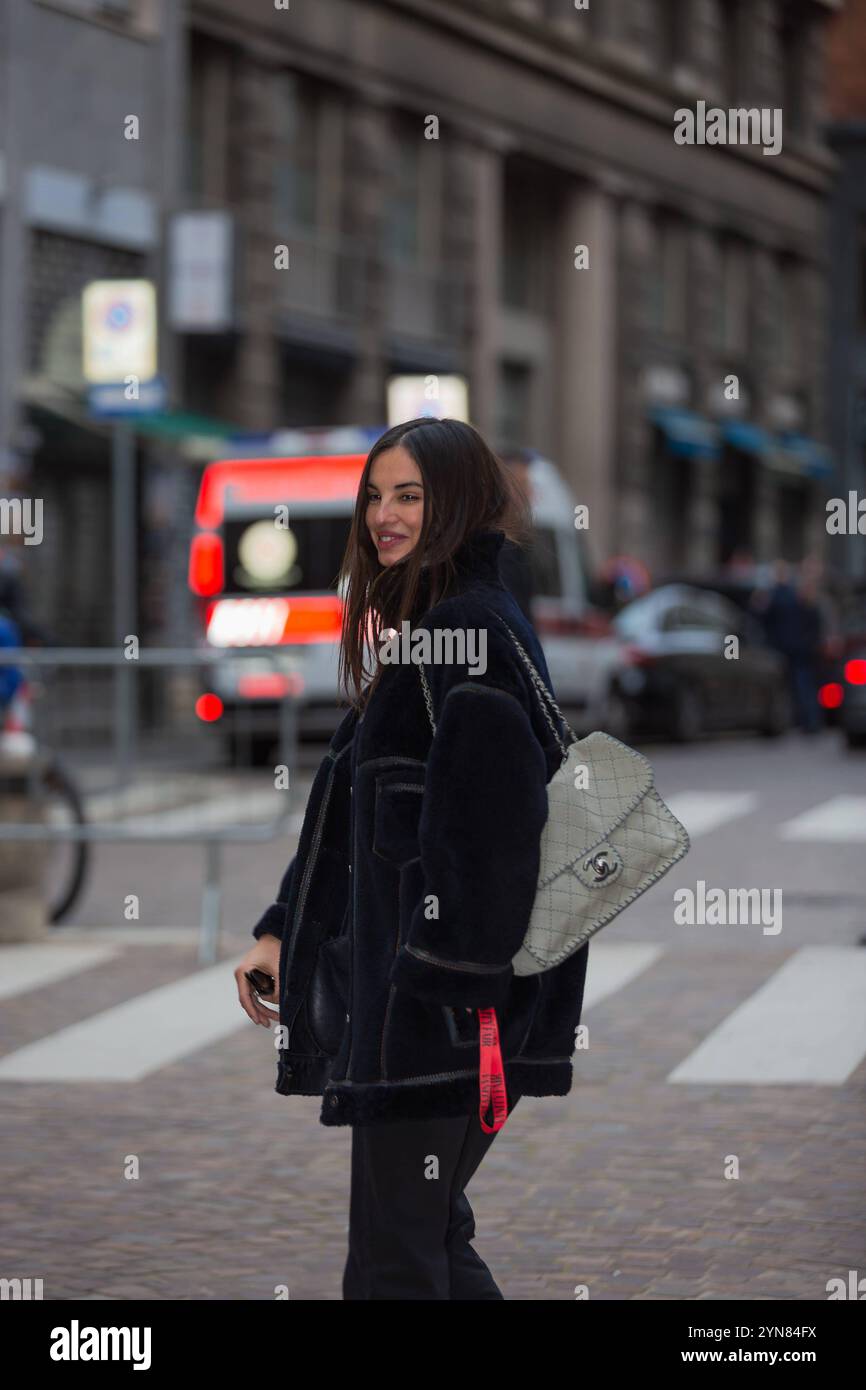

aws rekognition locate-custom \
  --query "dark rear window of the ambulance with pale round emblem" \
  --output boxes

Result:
[222,512,350,594]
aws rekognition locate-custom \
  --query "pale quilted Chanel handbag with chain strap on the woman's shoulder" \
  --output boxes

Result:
[418,609,689,974]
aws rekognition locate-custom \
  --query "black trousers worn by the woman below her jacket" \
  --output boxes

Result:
[343,1098,517,1300]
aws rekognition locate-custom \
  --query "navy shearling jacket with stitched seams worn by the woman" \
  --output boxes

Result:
[253,530,588,1125]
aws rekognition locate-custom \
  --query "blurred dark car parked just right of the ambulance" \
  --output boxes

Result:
[613,584,792,741]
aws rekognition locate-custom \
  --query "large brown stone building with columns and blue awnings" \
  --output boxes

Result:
[185,0,833,574]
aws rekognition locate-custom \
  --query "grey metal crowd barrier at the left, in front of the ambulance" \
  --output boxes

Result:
[0,648,304,965]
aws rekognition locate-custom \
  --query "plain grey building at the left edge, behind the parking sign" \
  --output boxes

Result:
[0,0,181,645]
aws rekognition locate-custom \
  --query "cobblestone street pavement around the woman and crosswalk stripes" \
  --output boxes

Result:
[0,737,866,1300]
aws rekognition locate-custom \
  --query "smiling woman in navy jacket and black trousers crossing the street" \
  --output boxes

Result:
[238,420,587,1300]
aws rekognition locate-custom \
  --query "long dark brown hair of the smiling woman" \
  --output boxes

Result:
[338,418,531,709]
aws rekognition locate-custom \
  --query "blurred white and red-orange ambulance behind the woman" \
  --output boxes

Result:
[189,452,620,742]
